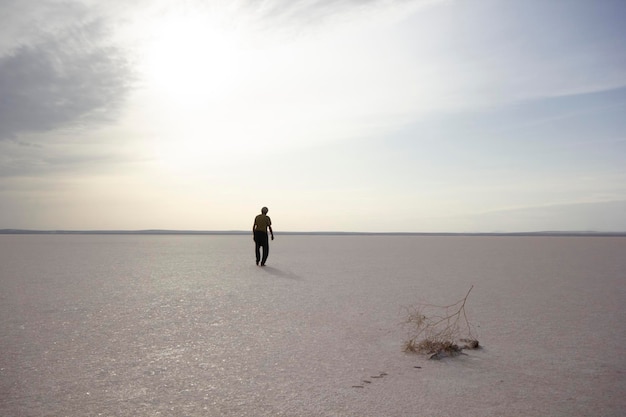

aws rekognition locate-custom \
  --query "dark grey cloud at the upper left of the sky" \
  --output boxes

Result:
[0,11,133,140]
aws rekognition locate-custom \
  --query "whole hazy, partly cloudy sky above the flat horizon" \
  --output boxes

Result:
[0,0,626,233]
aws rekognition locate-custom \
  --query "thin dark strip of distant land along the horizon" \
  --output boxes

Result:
[0,229,626,237]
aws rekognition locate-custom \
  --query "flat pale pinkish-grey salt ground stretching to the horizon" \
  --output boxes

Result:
[0,235,626,417]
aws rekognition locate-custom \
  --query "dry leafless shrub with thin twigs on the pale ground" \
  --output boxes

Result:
[403,286,480,359]
